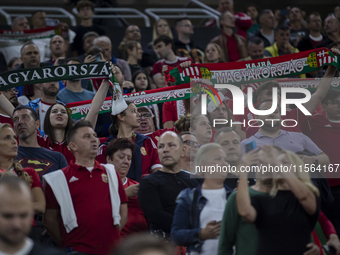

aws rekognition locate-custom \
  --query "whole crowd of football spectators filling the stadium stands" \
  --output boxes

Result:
[0,0,340,255]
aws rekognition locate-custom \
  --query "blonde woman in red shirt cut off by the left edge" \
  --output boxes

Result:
[0,123,46,214]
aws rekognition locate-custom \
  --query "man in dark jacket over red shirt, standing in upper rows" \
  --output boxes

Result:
[210,10,248,62]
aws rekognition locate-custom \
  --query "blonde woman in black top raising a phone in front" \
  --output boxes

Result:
[236,145,320,255]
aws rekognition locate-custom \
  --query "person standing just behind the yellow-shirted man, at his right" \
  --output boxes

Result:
[288,6,308,47]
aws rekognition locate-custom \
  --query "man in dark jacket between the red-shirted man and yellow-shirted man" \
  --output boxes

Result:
[254,9,275,47]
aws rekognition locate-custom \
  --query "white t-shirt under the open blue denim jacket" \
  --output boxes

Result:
[200,188,227,255]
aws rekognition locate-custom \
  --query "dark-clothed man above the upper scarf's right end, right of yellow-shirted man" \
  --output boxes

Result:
[297,12,324,51]
